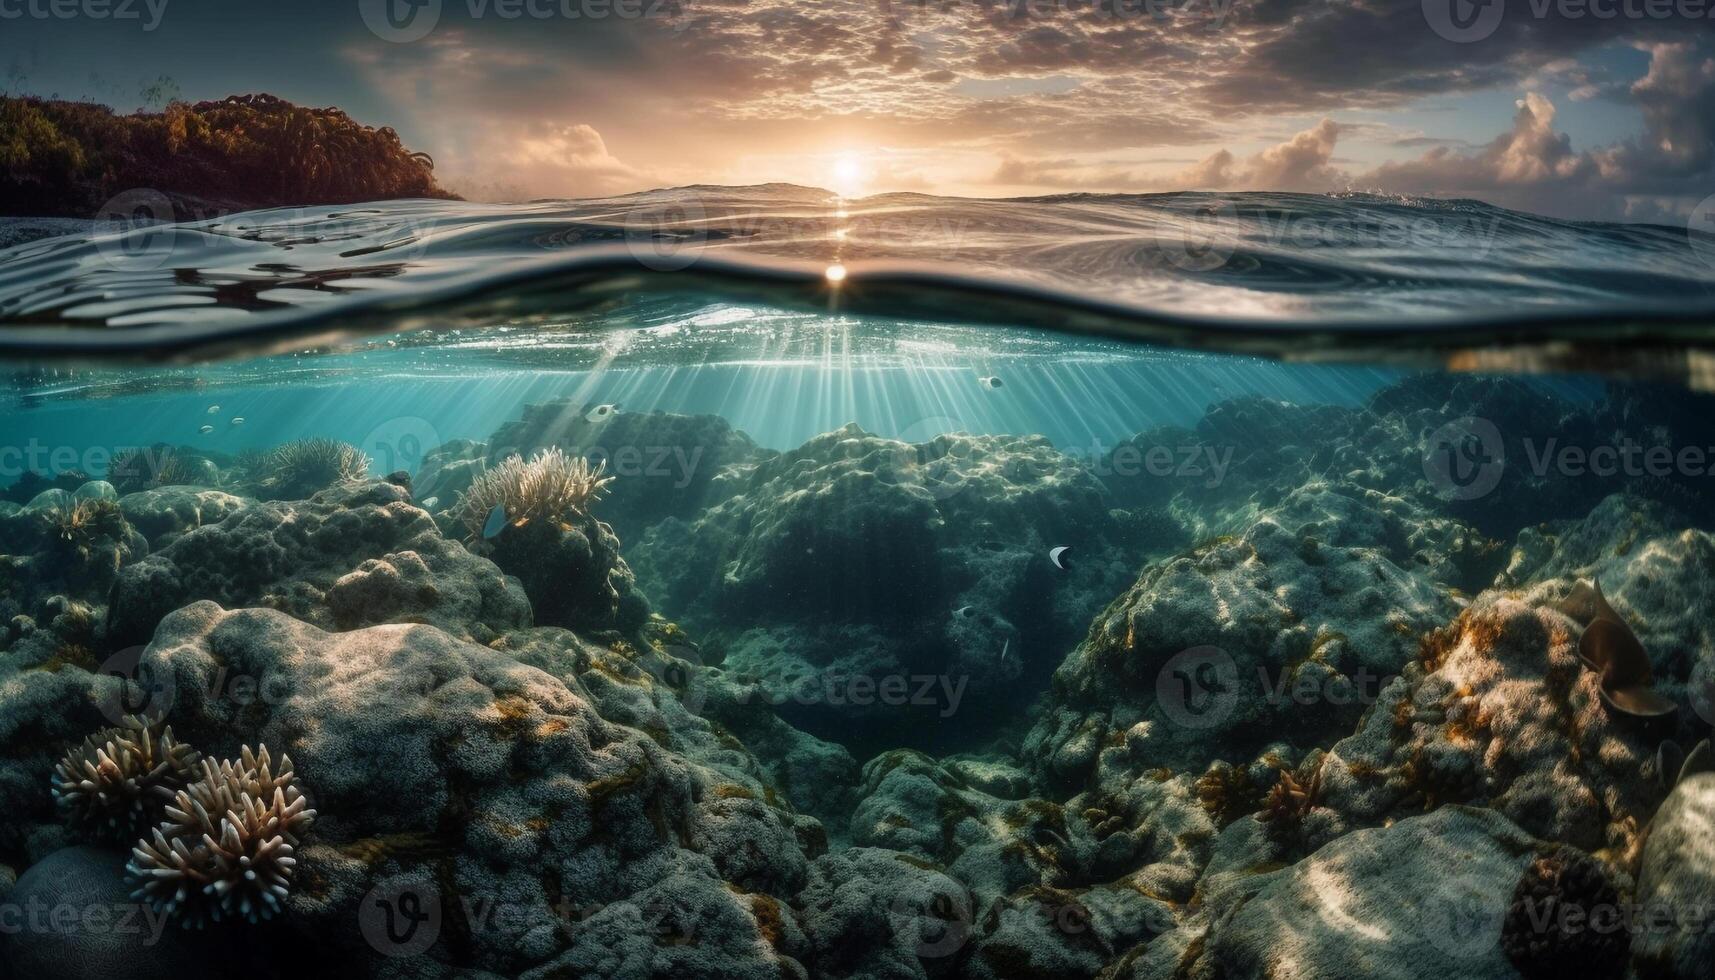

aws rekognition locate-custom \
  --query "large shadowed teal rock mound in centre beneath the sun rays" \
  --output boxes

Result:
[619,425,1128,745]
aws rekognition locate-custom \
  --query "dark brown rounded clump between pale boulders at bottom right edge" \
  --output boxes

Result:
[1501,846,1631,980]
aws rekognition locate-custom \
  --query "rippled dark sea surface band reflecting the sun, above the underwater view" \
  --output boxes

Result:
[0,184,1715,372]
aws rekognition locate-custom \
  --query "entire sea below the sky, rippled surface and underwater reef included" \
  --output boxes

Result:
[0,185,1715,978]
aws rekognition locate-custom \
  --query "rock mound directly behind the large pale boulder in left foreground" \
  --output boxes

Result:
[108,482,530,647]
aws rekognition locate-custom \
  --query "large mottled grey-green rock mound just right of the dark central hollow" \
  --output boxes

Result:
[1024,484,1458,788]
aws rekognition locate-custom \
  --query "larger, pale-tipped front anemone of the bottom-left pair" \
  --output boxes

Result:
[127,747,316,929]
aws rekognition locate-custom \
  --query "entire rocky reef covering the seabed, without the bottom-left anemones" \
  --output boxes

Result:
[0,378,1715,980]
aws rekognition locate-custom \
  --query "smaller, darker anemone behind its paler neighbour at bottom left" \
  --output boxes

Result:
[53,716,197,843]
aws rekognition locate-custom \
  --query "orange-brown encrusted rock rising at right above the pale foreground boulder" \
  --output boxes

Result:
[1322,592,1662,863]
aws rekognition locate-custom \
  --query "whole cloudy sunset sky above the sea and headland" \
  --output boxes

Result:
[0,0,1715,221]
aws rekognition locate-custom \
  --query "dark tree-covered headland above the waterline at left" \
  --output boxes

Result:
[0,94,458,220]
